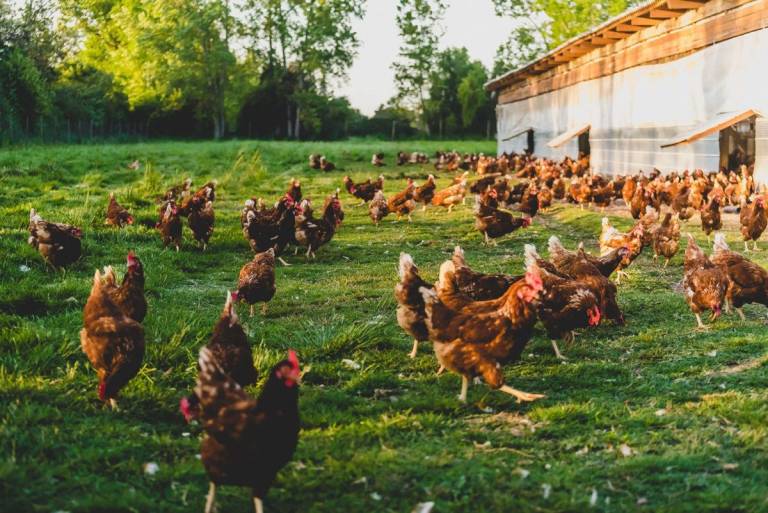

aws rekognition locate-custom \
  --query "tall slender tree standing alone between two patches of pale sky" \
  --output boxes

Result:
[392,0,446,136]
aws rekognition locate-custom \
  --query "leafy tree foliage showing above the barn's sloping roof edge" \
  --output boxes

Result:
[493,0,639,74]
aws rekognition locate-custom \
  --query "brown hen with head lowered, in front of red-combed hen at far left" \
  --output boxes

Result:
[80,270,145,409]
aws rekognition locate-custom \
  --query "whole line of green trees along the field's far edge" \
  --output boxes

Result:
[0,0,626,143]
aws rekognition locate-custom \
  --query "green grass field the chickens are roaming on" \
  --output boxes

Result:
[0,142,768,513]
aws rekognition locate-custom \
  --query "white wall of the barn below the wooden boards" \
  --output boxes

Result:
[497,29,768,178]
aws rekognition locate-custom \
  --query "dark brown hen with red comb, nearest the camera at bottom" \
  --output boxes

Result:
[195,348,301,513]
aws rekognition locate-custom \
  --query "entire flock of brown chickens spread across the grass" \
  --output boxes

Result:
[21,152,768,513]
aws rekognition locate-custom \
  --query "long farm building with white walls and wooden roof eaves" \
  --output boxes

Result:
[486,0,768,182]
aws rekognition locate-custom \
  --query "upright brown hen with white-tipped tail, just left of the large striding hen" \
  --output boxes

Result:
[395,253,434,358]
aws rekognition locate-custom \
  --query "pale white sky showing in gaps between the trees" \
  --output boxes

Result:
[336,0,511,115]
